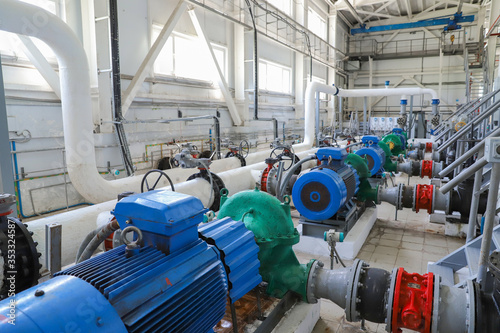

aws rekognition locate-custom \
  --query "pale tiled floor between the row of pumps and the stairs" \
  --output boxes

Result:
[297,177,465,333]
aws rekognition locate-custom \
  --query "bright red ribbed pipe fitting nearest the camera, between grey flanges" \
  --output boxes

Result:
[388,267,434,333]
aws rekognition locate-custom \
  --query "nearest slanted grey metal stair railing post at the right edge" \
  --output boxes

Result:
[477,163,500,289]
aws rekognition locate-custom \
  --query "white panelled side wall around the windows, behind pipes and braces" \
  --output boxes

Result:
[0,0,340,215]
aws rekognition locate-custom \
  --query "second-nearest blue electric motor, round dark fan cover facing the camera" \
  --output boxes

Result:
[292,148,359,221]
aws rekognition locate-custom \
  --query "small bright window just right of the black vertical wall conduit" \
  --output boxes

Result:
[259,59,292,94]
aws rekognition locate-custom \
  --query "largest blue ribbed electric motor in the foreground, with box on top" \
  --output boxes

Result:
[0,191,262,333]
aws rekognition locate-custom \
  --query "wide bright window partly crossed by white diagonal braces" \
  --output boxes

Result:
[152,25,227,81]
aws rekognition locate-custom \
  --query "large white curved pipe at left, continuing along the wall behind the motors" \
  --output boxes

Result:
[0,0,314,203]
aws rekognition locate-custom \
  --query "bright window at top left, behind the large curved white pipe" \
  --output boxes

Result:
[0,0,60,62]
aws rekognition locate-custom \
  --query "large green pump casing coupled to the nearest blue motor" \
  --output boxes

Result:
[218,188,314,301]
